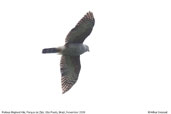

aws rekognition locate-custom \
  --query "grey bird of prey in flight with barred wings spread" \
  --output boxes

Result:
[42,11,95,94]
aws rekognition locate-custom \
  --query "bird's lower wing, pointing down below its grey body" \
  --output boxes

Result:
[60,55,81,93]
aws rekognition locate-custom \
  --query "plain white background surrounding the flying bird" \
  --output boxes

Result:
[0,0,171,114]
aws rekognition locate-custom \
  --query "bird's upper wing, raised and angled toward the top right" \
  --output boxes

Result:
[65,12,95,43]
